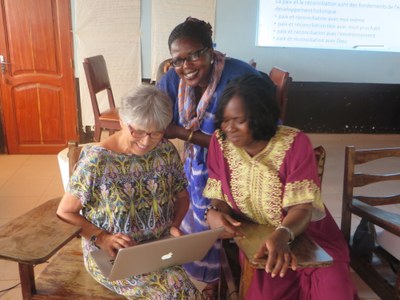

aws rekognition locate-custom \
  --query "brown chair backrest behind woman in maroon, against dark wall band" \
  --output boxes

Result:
[269,67,292,123]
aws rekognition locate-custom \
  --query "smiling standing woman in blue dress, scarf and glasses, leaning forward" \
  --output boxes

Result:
[157,17,258,298]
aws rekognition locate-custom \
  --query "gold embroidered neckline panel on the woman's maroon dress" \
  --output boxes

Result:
[217,126,299,225]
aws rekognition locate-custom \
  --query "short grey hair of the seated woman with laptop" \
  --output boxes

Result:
[119,84,172,131]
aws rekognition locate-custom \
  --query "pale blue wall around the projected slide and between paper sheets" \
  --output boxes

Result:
[78,0,400,84]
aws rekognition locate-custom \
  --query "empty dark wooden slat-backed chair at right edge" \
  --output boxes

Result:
[341,146,400,299]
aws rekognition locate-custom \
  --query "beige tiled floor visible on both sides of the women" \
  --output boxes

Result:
[0,134,400,300]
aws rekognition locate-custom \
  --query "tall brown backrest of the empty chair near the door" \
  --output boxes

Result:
[83,55,115,118]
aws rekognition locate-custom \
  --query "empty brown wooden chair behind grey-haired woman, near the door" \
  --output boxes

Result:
[83,55,121,142]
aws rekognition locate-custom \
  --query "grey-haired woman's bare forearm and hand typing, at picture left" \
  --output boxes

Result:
[57,192,133,256]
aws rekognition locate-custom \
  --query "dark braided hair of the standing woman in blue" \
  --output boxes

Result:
[168,17,213,50]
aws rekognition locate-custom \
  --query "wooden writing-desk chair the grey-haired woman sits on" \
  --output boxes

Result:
[0,142,125,300]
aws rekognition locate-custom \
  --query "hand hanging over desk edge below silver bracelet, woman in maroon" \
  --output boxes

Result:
[255,230,297,277]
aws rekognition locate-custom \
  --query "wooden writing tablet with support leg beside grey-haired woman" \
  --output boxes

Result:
[0,198,80,299]
